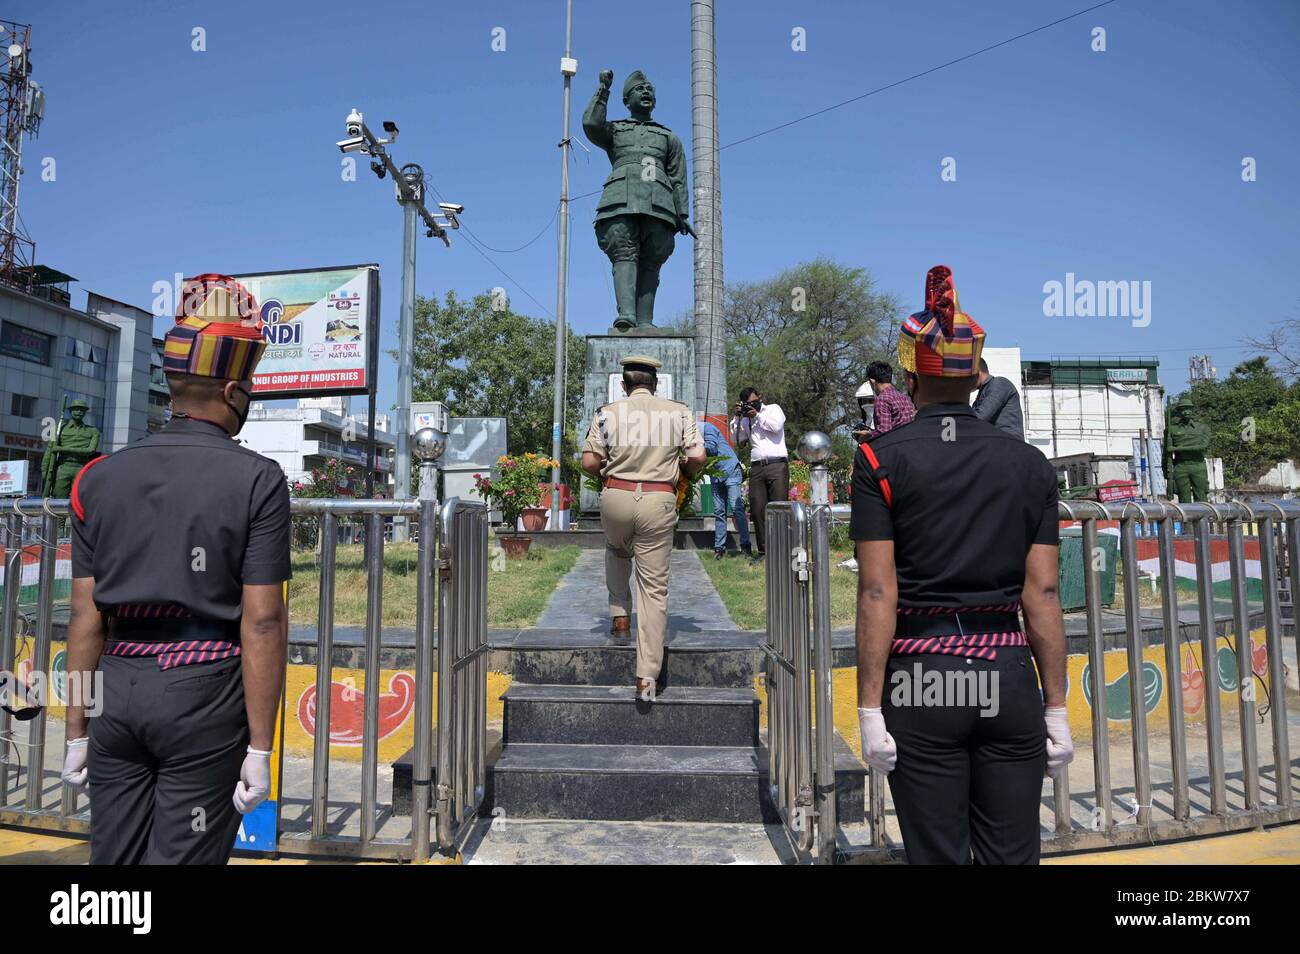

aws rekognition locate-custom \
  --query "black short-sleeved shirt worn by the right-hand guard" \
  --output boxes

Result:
[849,404,1060,608]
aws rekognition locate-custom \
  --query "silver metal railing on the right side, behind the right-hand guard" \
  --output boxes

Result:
[811,500,1300,851]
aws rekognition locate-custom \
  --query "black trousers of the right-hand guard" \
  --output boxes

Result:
[881,647,1047,864]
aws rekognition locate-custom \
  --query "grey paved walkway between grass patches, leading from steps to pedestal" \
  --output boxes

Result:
[536,550,736,633]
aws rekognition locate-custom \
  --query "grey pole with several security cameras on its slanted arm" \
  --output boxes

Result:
[337,108,464,541]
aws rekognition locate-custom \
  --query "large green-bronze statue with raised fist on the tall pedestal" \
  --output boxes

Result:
[582,70,696,331]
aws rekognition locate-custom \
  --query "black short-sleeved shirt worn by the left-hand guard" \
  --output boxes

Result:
[70,417,290,620]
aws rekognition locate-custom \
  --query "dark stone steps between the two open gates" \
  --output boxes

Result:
[394,629,866,824]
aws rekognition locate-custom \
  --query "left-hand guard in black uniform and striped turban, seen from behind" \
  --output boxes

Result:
[64,274,290,864]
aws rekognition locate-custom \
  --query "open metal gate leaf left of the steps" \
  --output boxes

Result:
[434,498,489,850]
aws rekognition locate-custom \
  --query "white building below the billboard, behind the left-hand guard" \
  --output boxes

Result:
[239,396,397,495]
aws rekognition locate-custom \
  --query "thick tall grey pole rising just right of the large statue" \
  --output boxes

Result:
[690,0,727,433]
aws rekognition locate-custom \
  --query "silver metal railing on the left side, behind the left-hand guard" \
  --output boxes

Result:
[0,498,488,860]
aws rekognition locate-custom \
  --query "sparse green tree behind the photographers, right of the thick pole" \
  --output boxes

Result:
[723,259,898,438]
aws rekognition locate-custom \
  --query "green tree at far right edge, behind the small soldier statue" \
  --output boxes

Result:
[1186,356,1300,486]
